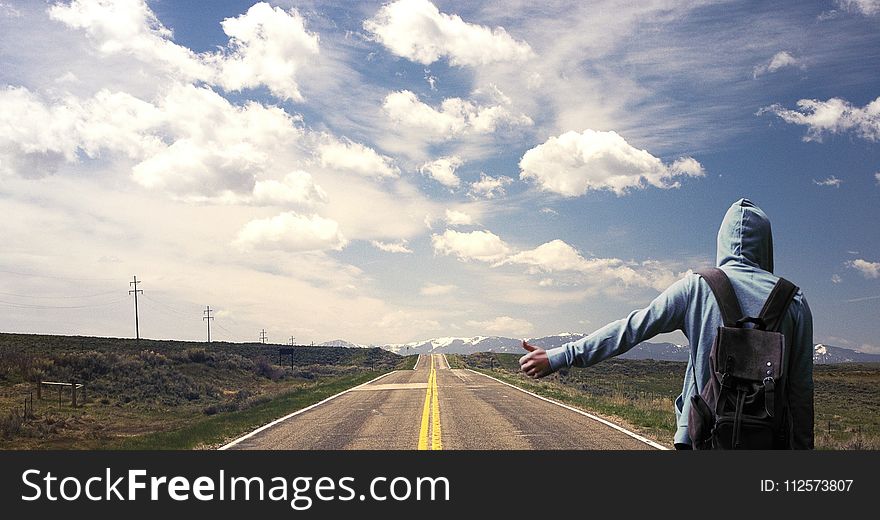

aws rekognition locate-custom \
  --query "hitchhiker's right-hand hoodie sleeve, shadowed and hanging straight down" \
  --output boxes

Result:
[788,296,814,450]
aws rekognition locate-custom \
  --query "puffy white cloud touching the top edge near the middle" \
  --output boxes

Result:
[364,0,533,66]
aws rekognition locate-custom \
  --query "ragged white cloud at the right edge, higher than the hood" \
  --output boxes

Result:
[758,97,880,142]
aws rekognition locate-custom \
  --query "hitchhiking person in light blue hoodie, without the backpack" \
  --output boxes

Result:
[520,199,813,449]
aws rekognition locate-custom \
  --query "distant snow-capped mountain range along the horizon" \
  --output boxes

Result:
[321,333,880,364]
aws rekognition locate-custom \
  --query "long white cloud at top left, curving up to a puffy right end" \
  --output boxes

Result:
[49,0,319,101]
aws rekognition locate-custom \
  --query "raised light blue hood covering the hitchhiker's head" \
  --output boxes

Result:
[716,199,773,273]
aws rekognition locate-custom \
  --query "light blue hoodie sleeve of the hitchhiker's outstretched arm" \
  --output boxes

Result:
[547,275,696,372]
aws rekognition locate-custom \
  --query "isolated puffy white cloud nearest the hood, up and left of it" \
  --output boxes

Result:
[519,129,705,197]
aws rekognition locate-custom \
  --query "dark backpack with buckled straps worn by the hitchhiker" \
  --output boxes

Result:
[688,268,798,450]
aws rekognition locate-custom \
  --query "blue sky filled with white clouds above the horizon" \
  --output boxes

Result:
[0,0,880,352]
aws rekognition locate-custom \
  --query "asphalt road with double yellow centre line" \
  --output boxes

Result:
[225,354,655,450]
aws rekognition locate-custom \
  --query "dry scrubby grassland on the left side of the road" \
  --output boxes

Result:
[0,334,402,449]
